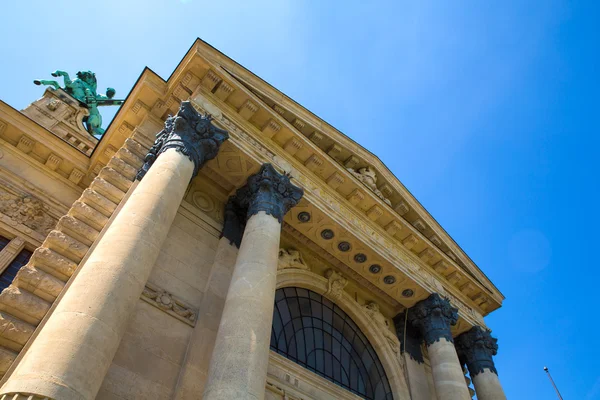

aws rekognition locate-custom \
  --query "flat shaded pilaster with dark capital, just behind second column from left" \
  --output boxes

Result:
[175,196,246,400]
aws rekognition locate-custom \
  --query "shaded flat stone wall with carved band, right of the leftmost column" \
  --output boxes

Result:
[97,203,218,400]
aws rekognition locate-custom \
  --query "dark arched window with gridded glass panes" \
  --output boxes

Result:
[271,287,393,400]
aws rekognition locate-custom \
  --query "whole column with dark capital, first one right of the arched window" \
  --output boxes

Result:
[408,293,471,400]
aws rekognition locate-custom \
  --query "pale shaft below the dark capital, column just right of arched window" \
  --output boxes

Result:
[427,338,471,400]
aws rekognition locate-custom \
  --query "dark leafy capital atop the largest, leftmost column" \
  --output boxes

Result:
[137,101,229,180]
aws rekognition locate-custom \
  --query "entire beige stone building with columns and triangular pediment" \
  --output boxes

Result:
[0,40,505,400]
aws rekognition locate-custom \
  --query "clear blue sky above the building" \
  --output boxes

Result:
[0,0,600,400]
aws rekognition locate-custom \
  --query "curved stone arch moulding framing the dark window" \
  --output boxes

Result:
[277,269,410,400]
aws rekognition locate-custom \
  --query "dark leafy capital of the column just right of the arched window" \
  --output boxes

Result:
[408,293,458,346]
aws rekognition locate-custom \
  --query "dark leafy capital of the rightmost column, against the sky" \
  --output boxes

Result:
[455,326,498,378]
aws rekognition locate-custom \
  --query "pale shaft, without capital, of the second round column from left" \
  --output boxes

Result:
[204,211,281,400]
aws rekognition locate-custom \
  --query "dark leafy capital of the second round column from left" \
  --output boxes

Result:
[236,164,304,223]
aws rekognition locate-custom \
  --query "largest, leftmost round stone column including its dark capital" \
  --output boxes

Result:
[0,102,228,400]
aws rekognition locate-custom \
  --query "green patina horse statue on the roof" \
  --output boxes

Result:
[33,71,123,139]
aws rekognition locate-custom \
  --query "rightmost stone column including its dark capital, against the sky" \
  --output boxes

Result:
[456,326,506,400]
